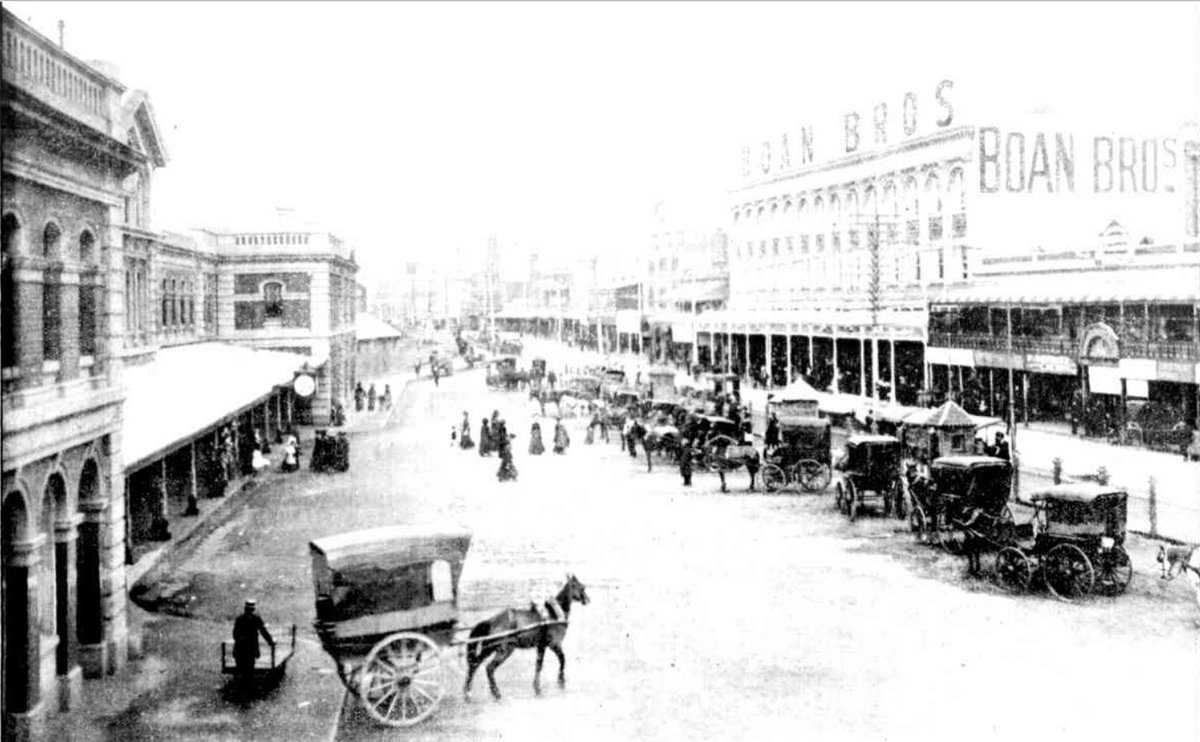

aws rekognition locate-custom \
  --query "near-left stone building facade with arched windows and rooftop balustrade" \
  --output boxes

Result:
[0,11,166,738]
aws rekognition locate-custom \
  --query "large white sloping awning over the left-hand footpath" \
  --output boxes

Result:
[121,342,320,469]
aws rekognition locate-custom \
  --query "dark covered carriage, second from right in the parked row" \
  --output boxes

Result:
[908,455,1013,551]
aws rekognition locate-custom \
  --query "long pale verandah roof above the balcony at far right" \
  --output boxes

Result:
[930,263,1200,305]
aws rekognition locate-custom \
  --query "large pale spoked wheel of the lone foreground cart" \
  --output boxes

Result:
[359,633,445,726]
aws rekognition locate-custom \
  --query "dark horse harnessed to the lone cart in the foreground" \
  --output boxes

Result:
[462,575,588,700]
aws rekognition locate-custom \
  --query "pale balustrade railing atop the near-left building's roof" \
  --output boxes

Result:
[2,13,119,134]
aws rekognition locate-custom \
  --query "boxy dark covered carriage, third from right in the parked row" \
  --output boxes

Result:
[835,435,904,521]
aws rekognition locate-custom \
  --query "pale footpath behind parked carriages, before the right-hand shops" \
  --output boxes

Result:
[524,339,1200,544]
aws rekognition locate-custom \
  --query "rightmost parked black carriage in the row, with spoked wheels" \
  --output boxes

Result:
[995,483,1133,600]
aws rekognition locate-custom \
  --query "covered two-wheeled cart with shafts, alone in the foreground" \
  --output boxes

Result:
[308,526,565,726]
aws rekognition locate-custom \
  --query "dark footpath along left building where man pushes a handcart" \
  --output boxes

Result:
[46,364,430,742]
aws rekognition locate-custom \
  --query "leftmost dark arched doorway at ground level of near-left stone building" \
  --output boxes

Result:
[0,491,38,725]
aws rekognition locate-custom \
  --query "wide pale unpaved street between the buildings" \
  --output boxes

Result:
[140,372,1200,741]
